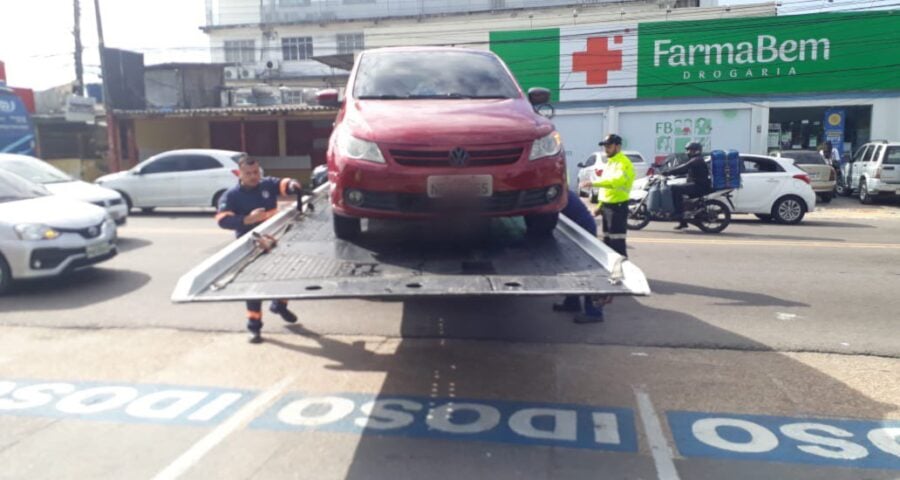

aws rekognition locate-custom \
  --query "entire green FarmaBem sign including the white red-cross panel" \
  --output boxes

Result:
[490,10,900,101]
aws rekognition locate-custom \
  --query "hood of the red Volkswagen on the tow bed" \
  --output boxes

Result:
[345,99,553,146]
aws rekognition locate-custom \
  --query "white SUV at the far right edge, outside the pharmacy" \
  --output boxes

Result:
[838,141,900,203]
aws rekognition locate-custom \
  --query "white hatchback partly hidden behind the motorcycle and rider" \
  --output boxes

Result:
[632,154,816,225]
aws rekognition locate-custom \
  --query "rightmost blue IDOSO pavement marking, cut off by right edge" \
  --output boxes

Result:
[667,411,900,470]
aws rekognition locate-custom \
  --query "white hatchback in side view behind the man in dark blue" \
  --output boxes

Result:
[97,149,246,212]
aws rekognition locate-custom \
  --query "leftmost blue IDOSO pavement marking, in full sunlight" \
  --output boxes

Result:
[0,380,254,426]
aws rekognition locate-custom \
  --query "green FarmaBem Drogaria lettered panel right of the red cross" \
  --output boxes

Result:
[638,11,900,98]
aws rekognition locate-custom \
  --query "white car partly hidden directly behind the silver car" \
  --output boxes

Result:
[0,153,128,225]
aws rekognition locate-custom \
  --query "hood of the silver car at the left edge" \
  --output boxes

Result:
[0,195,106,228]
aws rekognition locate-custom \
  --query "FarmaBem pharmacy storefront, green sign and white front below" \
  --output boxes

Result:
[490,11,900,176]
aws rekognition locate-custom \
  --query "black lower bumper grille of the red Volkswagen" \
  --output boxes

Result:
[350,185,561,213]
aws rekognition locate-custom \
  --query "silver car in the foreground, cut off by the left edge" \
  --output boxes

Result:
[0,170,117,293]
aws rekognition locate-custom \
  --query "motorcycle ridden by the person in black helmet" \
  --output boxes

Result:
[627,174,734,233]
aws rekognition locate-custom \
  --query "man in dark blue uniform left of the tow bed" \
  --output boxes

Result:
[216,156,302,343]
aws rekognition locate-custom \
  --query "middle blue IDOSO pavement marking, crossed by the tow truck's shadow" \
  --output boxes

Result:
[250,393,637,452]
